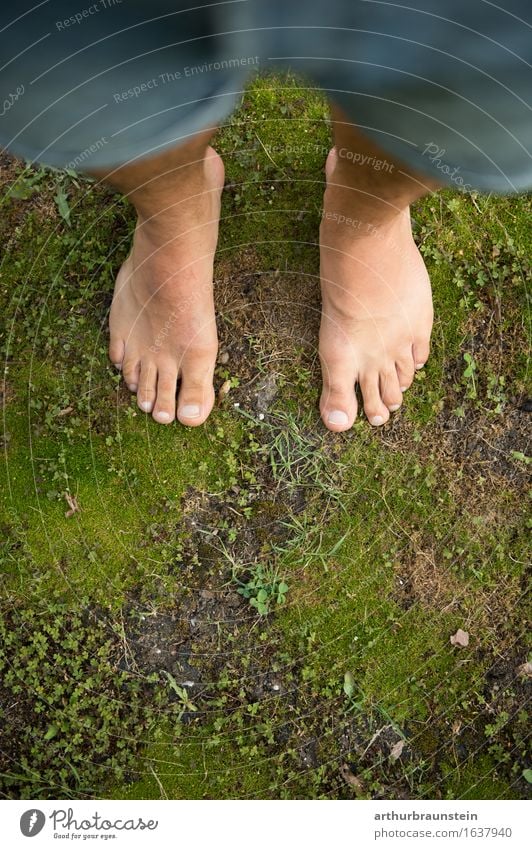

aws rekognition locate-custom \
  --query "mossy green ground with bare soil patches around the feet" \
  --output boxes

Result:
[0,77,532,799]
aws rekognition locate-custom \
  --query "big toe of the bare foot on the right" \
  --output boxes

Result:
[320,357,357,433]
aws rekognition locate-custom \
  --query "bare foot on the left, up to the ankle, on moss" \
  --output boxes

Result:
[109,148,224,425]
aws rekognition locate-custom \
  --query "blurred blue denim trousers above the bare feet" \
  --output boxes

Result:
[0,0,532,193]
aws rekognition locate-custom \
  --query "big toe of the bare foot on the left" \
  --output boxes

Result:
[177,346,217,427]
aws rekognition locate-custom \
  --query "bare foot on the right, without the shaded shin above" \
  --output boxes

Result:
[320,148,433,431]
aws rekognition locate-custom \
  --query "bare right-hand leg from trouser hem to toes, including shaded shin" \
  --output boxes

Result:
[320,109,437,431]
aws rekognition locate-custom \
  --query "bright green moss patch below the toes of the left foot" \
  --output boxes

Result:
[0,373,241,606]
